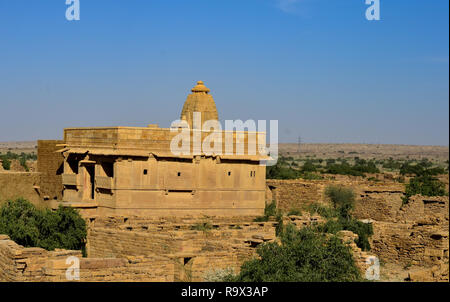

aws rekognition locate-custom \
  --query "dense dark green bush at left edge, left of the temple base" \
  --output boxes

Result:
[0,198,87,250]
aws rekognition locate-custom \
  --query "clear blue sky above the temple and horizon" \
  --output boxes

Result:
[0,0,449,146]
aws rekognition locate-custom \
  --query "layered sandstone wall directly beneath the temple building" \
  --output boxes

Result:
[87,217,277,281]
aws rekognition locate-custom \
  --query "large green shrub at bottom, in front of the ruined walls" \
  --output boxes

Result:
[229,225,361,282]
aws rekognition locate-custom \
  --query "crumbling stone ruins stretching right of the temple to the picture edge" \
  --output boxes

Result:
[267,178,449,281]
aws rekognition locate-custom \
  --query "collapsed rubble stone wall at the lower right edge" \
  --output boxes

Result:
[371,195,449,281]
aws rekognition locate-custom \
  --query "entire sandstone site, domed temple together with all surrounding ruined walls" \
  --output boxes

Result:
[0,82,449,281]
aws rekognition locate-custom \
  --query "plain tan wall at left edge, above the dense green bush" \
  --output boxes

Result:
[0,172,43,206]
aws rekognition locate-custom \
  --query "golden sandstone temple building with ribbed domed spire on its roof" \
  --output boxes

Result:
[57,81,267,216]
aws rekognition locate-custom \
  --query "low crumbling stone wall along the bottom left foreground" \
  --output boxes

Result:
[0,235,174,282]
